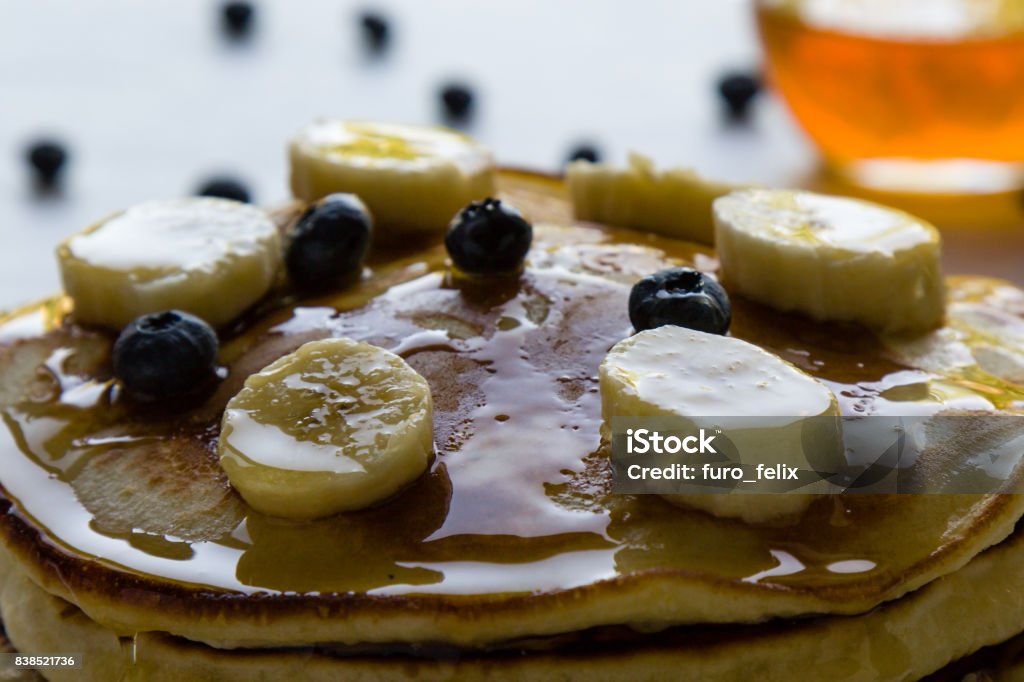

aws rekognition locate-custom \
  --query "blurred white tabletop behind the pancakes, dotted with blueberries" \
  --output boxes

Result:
[6,0,1024,309]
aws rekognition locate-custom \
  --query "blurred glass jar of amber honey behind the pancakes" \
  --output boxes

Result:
[757,0,1024,191]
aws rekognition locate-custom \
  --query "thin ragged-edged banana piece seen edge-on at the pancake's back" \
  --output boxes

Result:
[565,154,743,244]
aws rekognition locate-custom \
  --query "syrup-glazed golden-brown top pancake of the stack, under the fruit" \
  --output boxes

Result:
[0,173,1024,645]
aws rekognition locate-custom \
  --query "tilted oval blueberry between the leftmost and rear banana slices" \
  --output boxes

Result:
[285,194,374,291]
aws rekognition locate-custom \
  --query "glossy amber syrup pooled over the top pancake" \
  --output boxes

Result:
[0,223,1019,594]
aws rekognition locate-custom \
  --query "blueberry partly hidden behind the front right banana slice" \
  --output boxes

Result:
[630,267,732,334]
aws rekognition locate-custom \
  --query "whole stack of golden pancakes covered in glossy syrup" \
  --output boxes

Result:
[0,172,1024,680]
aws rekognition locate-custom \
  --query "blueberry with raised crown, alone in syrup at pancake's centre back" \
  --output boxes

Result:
[444,199,534,274]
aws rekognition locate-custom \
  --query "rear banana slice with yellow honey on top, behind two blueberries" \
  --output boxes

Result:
[289,119,495,235]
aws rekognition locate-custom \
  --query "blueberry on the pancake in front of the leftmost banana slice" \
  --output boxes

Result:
[114,310,217,400]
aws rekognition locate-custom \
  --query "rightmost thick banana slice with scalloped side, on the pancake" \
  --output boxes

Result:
[715,189,945,334]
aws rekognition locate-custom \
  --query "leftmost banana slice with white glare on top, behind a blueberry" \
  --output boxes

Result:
[57,198,281,329]
